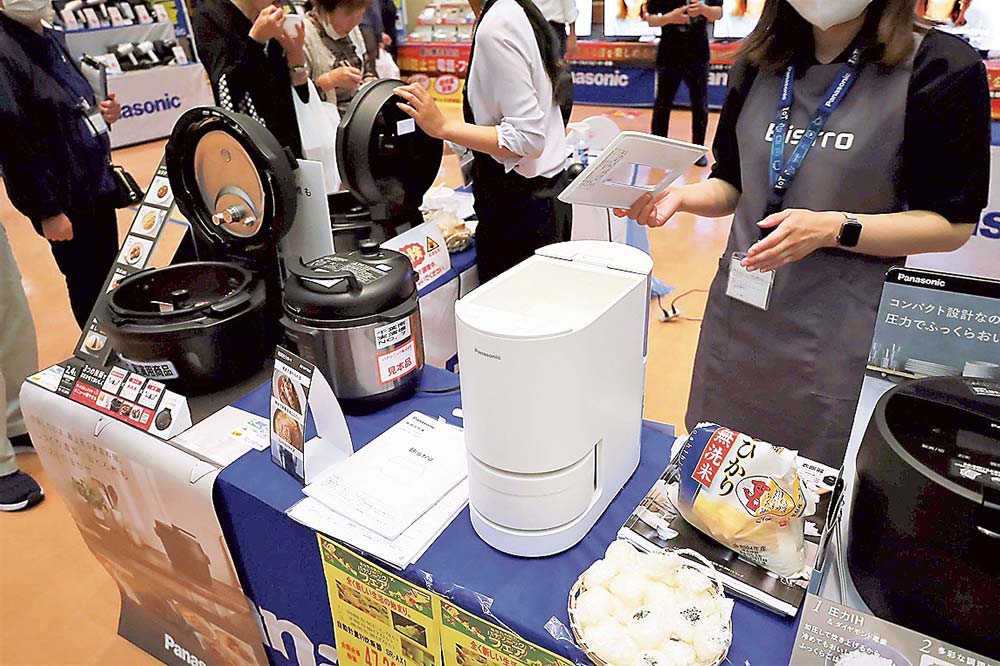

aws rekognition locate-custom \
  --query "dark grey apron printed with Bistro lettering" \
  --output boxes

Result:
[686,40,913,466]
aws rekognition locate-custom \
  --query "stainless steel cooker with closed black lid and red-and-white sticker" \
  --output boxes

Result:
[281,240,424,414]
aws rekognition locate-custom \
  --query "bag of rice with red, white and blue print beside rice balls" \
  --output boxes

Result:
[677,423,815,578]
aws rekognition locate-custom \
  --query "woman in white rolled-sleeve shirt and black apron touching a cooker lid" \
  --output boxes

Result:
[396,0,572,282]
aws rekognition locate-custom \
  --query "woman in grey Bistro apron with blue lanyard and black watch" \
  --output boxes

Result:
[619,0,990,465]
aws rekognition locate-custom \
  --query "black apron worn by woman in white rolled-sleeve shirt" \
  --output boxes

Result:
[462,3,573,283]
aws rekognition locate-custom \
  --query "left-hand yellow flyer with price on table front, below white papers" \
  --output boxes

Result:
[317,534,441,666]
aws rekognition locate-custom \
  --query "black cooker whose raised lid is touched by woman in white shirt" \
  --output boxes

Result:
[329,79,444,252]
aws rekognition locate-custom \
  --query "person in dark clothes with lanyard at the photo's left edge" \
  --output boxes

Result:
[0,0,121,328]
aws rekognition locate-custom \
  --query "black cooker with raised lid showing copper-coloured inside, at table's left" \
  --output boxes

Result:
[97,107,296,395]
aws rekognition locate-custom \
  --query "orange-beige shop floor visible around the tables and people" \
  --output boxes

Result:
[0,107,729,666]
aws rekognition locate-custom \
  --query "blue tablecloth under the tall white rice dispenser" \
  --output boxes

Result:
[215,368,796,666]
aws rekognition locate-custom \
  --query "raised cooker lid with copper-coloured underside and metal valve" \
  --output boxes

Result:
[165,107,297,259]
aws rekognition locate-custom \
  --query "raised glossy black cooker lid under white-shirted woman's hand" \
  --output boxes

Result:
[337,79,443,211]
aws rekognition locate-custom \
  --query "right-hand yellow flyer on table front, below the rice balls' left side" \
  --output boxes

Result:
[436,597,573,666]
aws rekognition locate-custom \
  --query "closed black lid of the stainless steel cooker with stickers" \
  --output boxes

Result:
[285,241,417,327]
